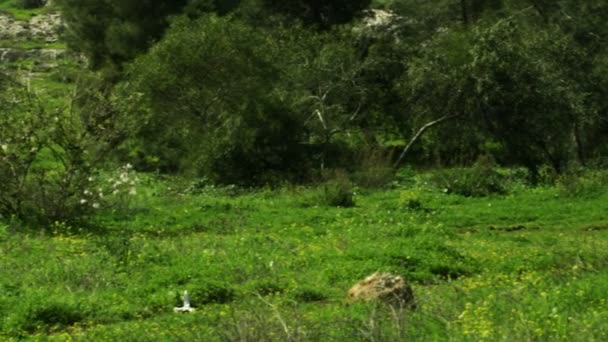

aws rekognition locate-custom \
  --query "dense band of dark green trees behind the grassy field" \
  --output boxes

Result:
[3,0,608,215]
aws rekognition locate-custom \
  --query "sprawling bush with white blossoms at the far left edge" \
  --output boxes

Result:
[0,75,127,225]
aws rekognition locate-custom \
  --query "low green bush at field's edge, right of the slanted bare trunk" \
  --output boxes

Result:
[431,157,507,197]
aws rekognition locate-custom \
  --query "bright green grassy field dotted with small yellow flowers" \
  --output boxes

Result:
[0,172,608,341]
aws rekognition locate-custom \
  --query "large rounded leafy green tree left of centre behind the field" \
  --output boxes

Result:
[116,16,302,183]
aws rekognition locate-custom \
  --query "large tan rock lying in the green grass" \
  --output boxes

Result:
[348,273,416,309]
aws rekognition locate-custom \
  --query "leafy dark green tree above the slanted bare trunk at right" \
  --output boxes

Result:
[396,19,584,171]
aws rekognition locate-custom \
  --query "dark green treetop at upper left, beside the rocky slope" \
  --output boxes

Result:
[57,0,240,69]
